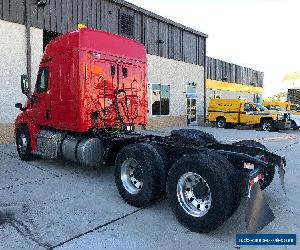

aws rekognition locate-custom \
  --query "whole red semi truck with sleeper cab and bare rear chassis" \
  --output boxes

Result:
[15,28,286,233]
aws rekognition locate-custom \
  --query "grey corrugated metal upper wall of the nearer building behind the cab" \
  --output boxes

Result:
[0,0,206,65]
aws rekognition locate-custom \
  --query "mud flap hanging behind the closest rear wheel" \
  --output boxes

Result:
[246,174,275,233]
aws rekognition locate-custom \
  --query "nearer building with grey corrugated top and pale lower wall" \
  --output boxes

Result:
[0,0,262,142]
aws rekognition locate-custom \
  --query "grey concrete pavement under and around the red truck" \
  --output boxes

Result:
[0,128,300,249]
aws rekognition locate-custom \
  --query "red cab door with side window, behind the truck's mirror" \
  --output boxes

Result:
[31,66,51,126]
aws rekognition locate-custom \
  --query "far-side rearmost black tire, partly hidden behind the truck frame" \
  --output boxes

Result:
[232,140,275,190]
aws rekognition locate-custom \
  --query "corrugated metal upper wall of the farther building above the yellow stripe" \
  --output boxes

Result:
[206,57,264,87]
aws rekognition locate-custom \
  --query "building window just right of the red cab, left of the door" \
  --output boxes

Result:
[151,83,170,115]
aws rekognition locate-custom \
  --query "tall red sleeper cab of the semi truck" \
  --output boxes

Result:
[17,29,148,135]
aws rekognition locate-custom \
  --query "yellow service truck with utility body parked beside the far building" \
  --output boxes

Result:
[208,99,290,131]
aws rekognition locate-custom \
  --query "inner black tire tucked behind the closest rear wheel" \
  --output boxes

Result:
[209,152,243,217]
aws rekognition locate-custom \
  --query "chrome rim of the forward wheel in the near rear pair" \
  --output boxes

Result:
[121,158,143,194]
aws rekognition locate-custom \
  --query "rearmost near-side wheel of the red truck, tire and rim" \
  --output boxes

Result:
[167,153,232,233]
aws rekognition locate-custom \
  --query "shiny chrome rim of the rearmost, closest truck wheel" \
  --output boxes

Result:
[177,172,212,217]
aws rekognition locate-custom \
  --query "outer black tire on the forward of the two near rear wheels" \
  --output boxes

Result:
[115,143,166,207]
